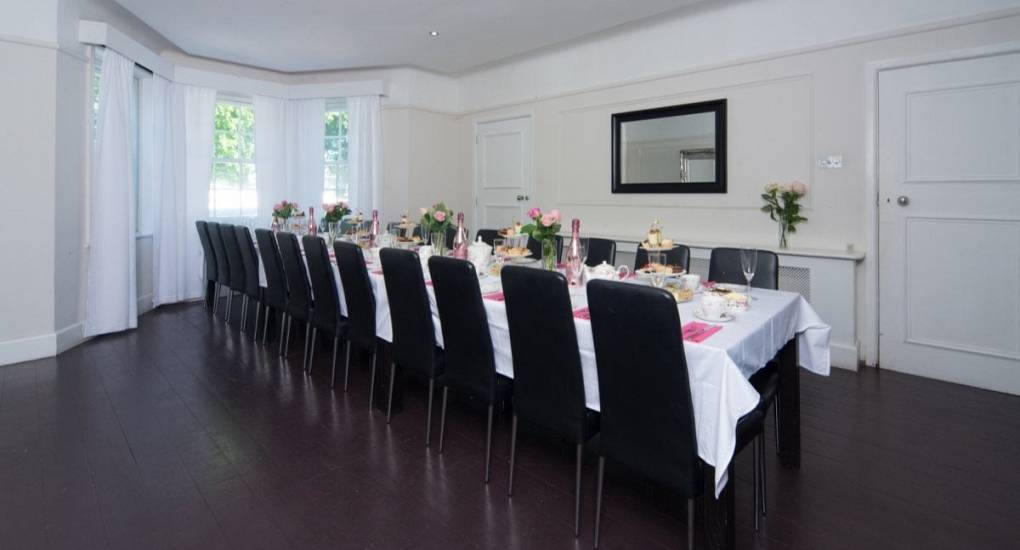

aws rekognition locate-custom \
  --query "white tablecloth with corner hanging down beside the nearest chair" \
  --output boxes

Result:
[263,247,830,497]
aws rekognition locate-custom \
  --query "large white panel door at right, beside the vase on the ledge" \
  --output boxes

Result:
[878,54,1020,394]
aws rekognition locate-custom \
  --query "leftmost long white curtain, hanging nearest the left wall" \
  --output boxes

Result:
[85,49,138,337]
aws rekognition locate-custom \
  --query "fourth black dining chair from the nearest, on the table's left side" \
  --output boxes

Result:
[379,248,444,432]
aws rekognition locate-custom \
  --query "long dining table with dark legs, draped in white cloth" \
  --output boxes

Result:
[262,238,830,548]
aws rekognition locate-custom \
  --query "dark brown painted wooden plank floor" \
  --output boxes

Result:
[0,305,1020,549]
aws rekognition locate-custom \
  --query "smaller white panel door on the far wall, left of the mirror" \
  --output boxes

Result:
[474,116,533,229]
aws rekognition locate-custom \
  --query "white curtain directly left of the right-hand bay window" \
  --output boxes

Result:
[285,98,325,217]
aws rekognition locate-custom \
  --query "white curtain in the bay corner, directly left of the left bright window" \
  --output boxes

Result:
[152,80,216,306]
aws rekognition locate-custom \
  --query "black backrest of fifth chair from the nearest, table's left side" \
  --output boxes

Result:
[333,241,375,349]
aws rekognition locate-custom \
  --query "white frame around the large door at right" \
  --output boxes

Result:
[860,41,1020,367]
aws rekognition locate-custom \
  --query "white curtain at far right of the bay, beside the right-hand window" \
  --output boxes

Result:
[347,96,383,214]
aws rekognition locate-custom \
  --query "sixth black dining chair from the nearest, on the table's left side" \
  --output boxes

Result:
[301,235,347,381]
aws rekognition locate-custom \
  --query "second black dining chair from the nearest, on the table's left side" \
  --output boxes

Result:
[501,265,599,537]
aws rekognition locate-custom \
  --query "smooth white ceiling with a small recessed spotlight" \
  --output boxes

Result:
[116,0,718,73]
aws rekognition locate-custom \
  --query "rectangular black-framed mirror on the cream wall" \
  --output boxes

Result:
[612,99,726,193]
